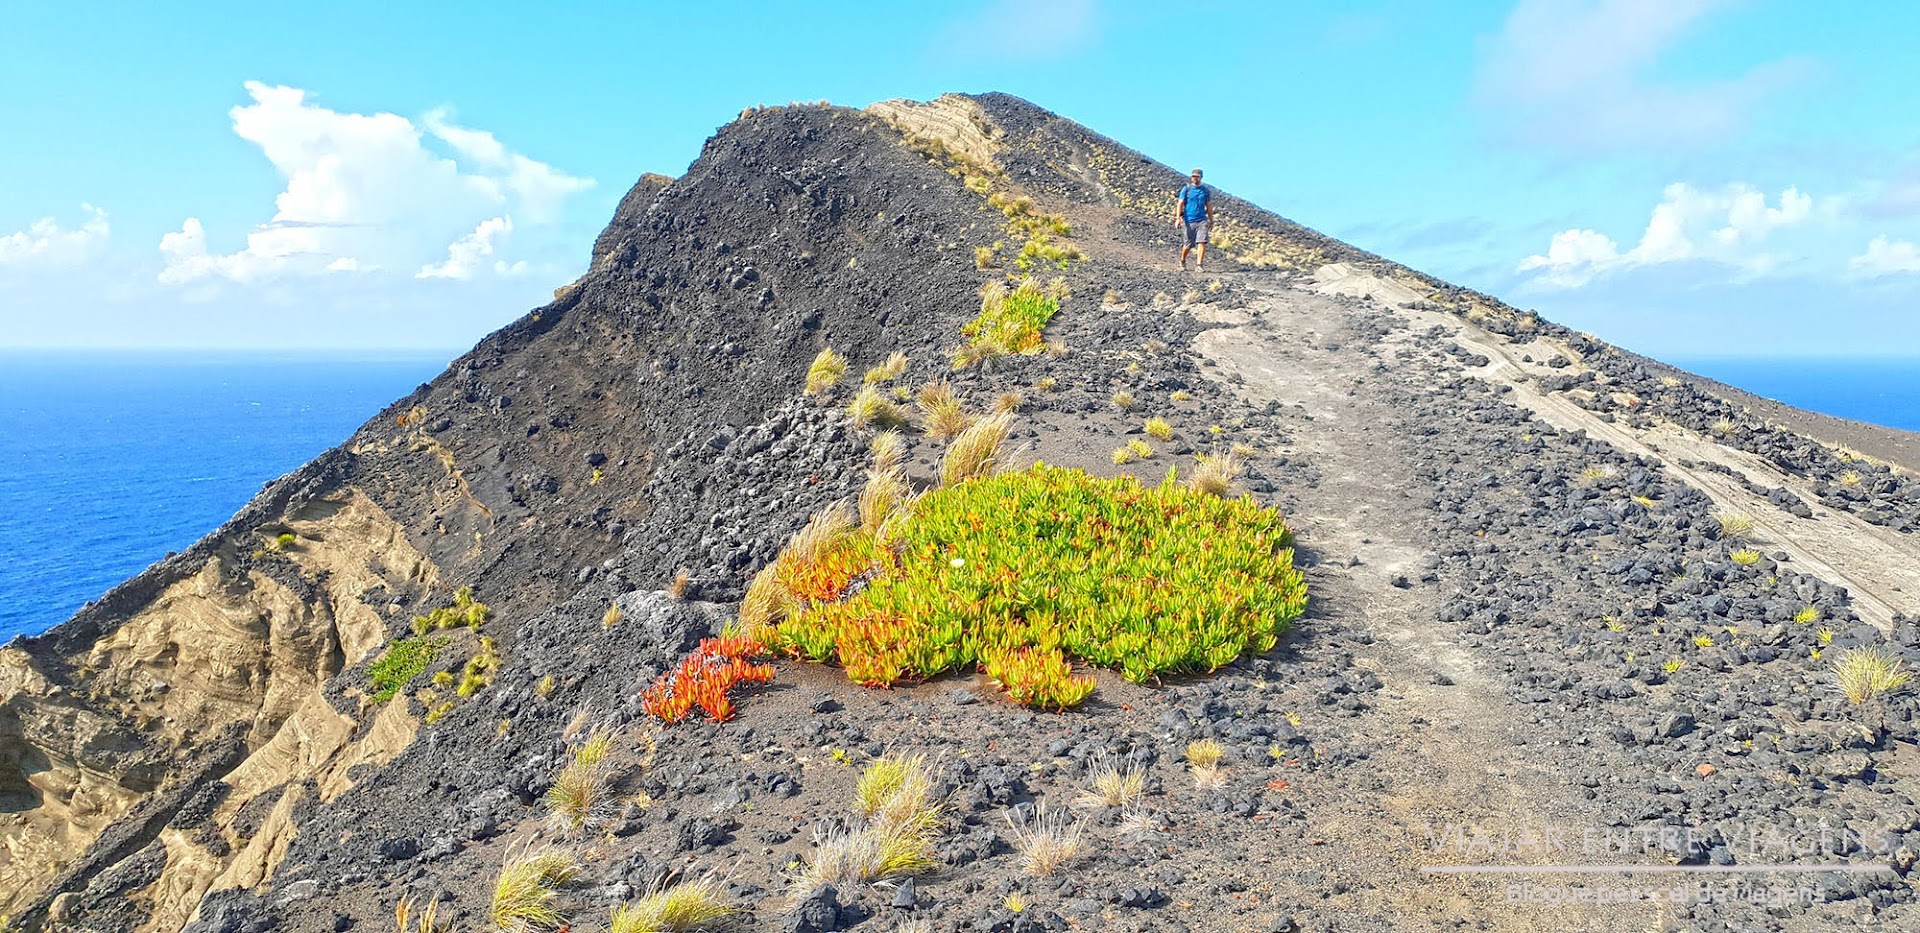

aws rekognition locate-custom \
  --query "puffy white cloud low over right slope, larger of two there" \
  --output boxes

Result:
[1519,182,1814,288]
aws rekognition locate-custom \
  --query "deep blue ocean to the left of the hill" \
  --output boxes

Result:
[0,351,457,641]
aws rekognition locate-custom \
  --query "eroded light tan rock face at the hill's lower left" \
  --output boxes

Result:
[0,490,438,917]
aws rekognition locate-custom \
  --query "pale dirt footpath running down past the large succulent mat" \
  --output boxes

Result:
[1194,290,1657,931]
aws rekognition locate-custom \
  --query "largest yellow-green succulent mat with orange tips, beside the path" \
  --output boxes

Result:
[768,465,1306,706]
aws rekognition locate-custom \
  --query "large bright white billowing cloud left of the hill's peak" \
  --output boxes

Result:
[159,83,593,284]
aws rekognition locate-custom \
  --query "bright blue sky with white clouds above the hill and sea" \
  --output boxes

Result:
[0,0,1920,357]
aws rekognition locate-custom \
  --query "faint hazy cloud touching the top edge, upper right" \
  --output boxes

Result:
[1478,0,1805,152]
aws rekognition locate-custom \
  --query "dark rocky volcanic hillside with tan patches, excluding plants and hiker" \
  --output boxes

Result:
[0,94,1920,933]
